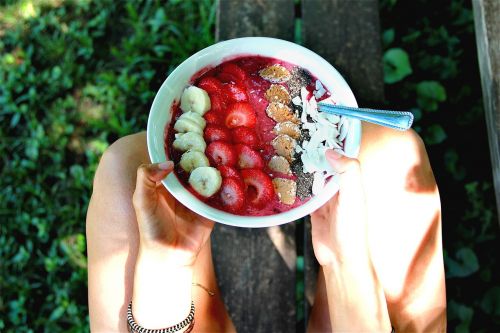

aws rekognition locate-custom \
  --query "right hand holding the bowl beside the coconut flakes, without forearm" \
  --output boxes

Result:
[311,150,368,266]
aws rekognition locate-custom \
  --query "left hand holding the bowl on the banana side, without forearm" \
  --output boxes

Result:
[133,161,214,266]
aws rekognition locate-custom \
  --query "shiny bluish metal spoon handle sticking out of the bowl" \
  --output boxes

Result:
[318,103,413,131]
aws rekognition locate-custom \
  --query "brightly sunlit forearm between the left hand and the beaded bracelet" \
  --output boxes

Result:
[132,250,193,329]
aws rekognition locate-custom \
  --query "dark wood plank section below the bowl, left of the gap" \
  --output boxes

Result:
[212,223,296,332]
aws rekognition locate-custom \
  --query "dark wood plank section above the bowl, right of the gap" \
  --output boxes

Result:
[302,0,384,105]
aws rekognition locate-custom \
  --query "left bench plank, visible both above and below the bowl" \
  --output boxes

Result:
[212,0,296,333]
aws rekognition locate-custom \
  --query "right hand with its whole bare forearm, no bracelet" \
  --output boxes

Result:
[311,150,391,332]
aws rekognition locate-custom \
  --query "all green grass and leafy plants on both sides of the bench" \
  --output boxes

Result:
[0,0,500,332]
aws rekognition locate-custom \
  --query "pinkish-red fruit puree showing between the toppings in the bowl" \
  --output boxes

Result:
[165,56,326,216]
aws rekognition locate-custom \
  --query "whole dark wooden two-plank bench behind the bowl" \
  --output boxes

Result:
[212,0,384,333]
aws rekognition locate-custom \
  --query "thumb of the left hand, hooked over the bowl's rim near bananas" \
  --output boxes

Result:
[133,161,174,209]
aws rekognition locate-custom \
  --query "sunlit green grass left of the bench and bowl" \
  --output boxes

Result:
[0,1,215,332]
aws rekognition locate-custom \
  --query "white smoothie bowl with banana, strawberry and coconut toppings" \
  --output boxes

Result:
[147,37,361,227]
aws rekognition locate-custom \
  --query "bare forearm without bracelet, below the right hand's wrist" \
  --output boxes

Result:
[323,258,391,333]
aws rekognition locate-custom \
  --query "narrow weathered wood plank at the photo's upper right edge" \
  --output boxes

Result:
[472,0,500,223]
